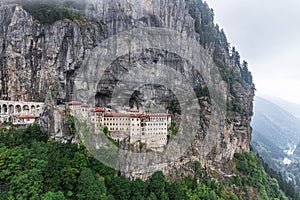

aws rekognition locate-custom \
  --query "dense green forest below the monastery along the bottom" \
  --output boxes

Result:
[0,124,299,200]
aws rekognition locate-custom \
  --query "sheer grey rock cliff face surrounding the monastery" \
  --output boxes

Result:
[0,0,254,177]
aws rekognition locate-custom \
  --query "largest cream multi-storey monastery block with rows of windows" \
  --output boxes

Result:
[101,113,171,148]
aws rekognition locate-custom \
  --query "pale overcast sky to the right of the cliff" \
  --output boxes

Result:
[206,0,300,104]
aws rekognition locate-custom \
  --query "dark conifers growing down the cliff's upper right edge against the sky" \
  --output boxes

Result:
[186,0,254,116]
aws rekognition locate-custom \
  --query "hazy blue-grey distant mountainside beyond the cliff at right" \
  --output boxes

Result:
[251,97,300,192]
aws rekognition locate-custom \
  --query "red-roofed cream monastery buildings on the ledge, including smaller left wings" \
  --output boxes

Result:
[69,101,171,148]
